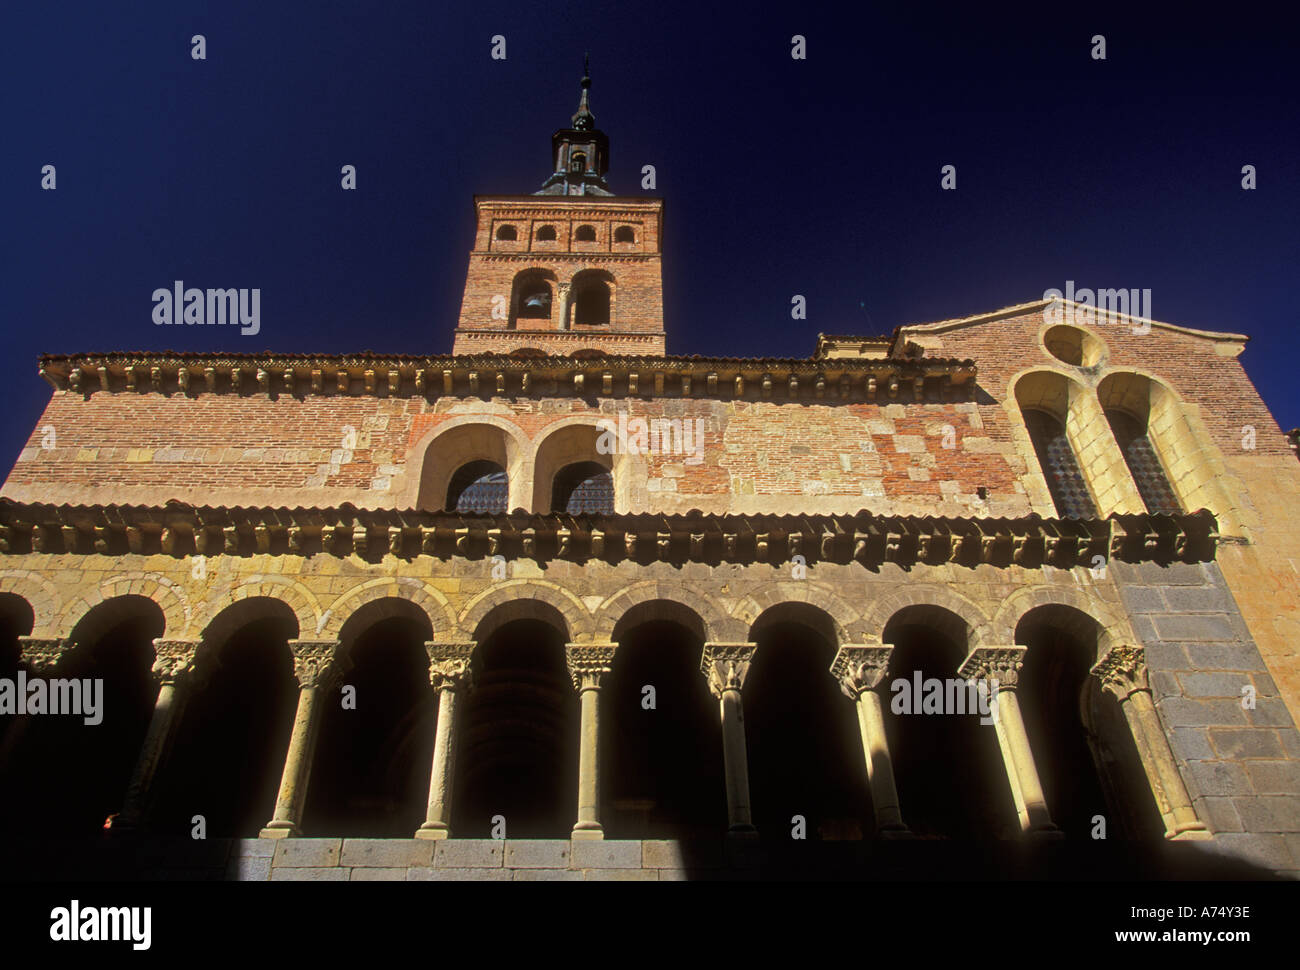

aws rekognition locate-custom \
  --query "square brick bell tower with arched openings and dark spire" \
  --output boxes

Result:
[451,64,664,356]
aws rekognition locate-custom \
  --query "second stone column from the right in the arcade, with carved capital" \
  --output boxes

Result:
[959,646,1061,839]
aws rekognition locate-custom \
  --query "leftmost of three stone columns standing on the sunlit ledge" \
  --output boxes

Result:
[261,640,347,839]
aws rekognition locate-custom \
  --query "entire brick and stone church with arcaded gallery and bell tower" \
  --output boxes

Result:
[0,69,1300,879]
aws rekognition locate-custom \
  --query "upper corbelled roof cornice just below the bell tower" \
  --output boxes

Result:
[40,348,976,403]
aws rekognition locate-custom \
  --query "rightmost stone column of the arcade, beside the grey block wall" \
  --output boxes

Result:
[1092,646,1210,841]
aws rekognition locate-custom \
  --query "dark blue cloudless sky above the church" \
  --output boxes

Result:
[0,0,1300,468]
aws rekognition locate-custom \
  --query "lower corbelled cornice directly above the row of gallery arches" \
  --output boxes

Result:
[0,499,1218,570]
